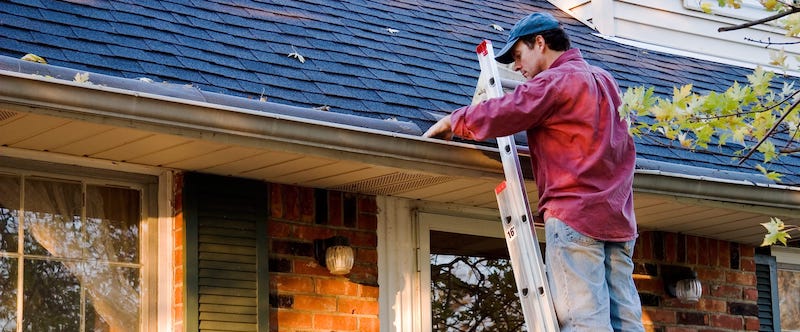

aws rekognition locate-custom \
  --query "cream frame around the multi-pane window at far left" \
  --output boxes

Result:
[0,157,160,331]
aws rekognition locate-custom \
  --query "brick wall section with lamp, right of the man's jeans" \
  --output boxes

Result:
[634,232,759,332]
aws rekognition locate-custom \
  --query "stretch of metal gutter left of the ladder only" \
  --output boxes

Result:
[0,71,502,178]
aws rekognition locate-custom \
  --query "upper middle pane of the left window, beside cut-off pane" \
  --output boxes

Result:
[24,179,87,258]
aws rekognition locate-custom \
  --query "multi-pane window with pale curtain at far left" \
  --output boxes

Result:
[0,172,146,332]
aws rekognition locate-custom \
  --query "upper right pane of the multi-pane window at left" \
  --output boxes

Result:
[86,186,141,263]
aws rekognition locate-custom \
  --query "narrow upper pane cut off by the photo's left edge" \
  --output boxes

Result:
[0,175,20,252]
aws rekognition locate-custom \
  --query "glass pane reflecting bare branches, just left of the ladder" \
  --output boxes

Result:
[431,231,525,331]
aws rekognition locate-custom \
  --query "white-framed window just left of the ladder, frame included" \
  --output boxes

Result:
[418,213,544,331]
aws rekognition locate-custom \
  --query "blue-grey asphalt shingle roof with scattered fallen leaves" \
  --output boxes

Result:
[0,0,800,185]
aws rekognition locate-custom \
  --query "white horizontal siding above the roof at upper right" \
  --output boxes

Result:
[552,0,800,69]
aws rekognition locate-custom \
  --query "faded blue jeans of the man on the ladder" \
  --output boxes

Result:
[545,218,644,332]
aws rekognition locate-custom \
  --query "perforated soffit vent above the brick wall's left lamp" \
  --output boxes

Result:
[331,173,453,195]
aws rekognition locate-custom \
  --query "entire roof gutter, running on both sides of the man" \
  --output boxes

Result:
[0,71,800,210]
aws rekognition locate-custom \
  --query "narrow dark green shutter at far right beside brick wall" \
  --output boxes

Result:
[755,255,781,331]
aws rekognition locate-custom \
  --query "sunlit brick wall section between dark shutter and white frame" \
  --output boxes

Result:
[269,184,380,332]
